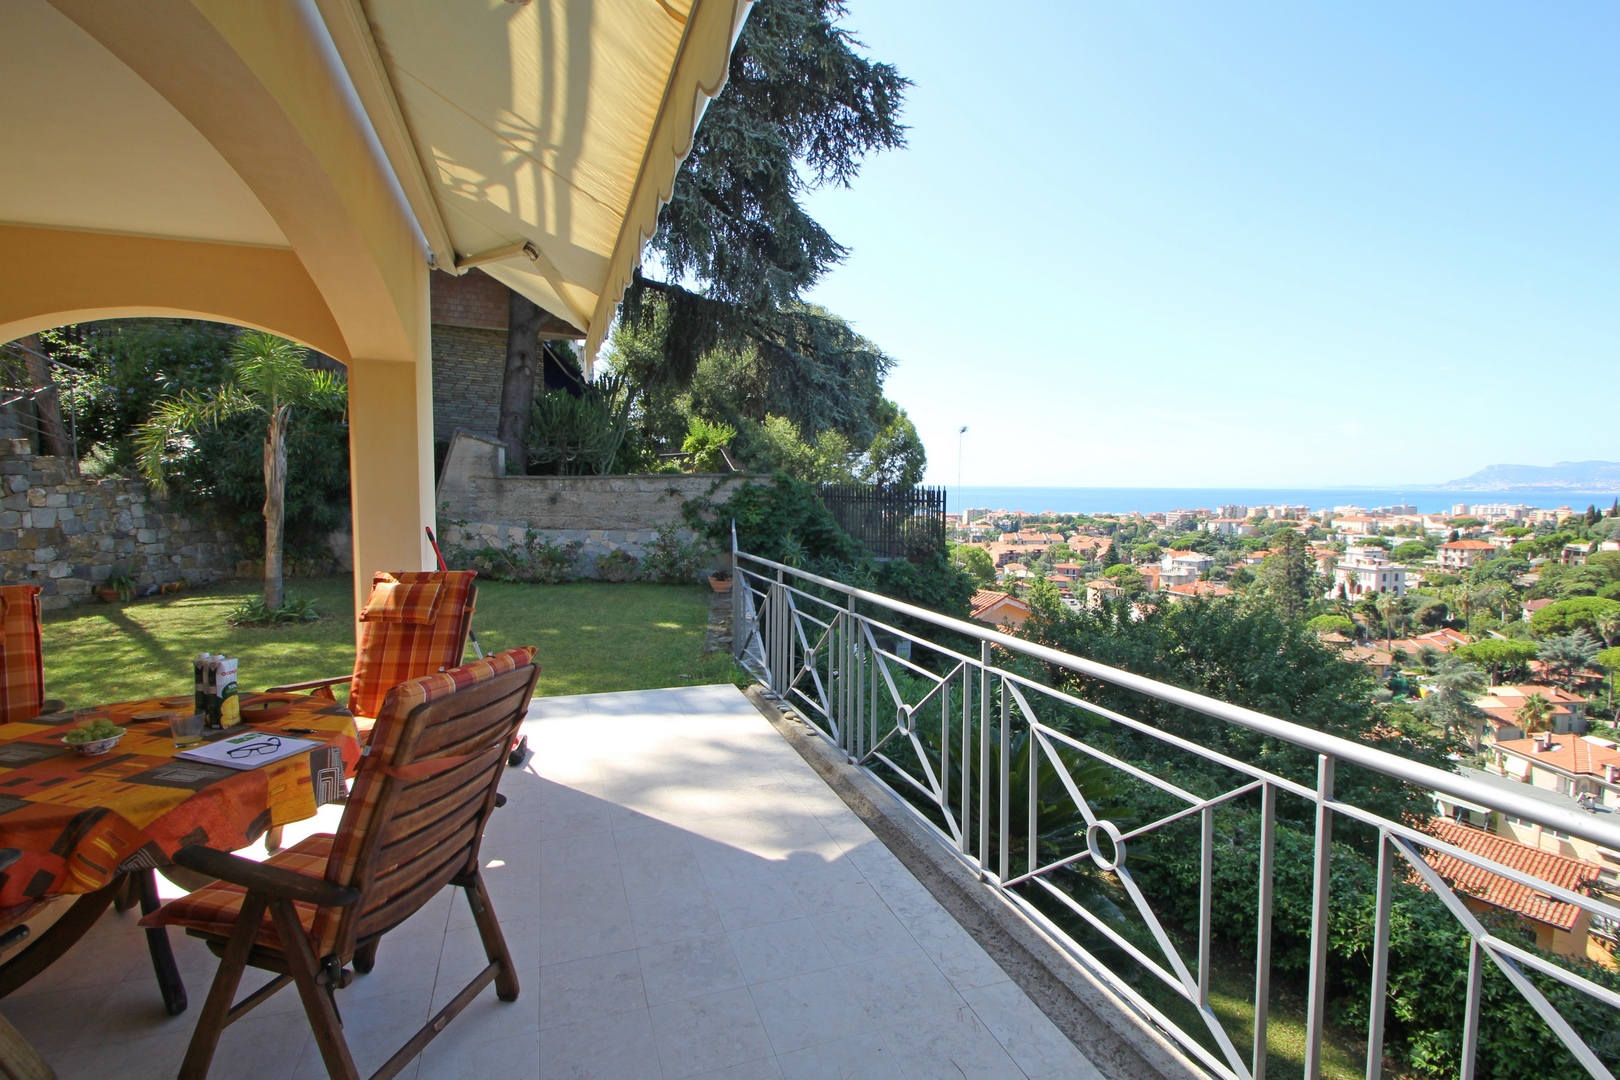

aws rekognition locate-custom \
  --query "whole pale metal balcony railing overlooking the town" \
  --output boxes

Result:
[732,541,1620,1080]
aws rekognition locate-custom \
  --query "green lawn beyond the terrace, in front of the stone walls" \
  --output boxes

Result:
[44,578,734,704]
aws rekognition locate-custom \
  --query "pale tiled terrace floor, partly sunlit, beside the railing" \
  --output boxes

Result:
[0,687,1097,1080]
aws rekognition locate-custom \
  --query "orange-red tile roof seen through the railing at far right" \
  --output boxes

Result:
[1424,818,1599,929]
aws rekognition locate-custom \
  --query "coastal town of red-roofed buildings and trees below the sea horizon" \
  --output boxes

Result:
[948,502,1620,965]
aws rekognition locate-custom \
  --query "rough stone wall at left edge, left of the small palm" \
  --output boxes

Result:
[0,442,243,609]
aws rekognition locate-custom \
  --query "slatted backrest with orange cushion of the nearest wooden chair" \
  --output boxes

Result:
[314,649,539,957]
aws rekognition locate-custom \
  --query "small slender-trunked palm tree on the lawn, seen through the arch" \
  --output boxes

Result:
[134,330,347,610]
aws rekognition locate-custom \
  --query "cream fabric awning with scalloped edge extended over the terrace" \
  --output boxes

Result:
[358,0,752,356]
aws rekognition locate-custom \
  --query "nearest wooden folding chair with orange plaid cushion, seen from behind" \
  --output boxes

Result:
[141,648,539,1080]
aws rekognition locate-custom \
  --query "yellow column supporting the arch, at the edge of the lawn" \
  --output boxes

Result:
[348,267,437,628]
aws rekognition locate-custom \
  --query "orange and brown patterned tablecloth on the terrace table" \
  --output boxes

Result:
[0,695,360,915]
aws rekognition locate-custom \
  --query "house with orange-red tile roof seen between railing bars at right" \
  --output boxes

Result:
[1424,818,1612,963]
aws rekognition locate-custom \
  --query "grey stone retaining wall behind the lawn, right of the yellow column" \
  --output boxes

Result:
[437,432,757,576]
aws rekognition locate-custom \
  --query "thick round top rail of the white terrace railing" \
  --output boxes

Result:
[732,544,1620,852]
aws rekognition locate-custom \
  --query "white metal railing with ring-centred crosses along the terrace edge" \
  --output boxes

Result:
[732,534,1620,1080]
